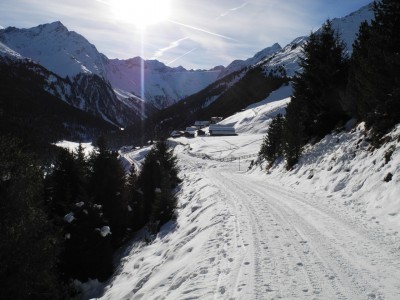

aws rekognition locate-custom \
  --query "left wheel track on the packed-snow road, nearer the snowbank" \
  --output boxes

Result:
[212,170,316,299]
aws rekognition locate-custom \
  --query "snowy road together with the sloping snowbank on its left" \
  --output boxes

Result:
[99,153,400,300]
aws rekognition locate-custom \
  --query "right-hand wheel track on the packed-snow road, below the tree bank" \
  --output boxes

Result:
[219,169,400,299]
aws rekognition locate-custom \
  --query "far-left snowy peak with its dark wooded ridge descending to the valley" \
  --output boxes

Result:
[0,22,144,126]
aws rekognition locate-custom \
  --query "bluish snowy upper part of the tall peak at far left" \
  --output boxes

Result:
[0,22,105,78]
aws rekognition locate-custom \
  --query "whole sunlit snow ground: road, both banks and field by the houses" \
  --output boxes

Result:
[90,88,400,300]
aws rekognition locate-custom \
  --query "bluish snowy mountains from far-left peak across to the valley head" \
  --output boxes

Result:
[0,22,225,108]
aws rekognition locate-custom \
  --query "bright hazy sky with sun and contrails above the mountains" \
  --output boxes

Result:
[0,0,371,69]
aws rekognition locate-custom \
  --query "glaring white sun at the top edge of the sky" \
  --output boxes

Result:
[110,0,171,28]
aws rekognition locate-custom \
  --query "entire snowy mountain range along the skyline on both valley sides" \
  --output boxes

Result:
[0,1,373,144]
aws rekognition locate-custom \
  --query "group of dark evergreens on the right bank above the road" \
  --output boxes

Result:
[262,1,400,169]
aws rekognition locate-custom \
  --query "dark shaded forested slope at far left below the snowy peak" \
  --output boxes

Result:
[0,57,118,161]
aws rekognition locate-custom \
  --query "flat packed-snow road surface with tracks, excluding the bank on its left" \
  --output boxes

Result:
[209,168,400,299]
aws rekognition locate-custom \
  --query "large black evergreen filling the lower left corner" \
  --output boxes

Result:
[0,137,65,299]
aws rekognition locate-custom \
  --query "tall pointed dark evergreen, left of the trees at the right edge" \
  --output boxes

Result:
[289,20,348,139]
